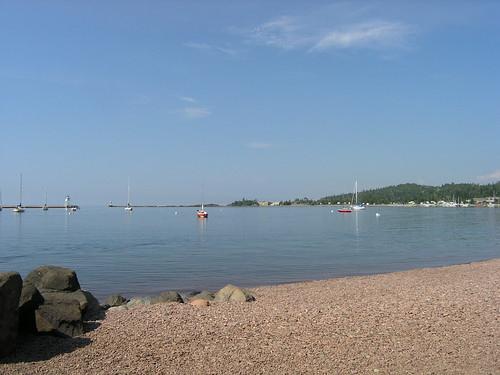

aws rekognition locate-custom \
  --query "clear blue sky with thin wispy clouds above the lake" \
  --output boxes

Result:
[0,0,500,205]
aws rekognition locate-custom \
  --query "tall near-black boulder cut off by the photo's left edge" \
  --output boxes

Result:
[0,272,23,357]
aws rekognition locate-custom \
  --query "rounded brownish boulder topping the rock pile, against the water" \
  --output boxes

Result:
[24,266,80,292]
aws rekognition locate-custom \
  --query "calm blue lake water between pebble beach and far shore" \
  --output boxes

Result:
[0,206,500,298]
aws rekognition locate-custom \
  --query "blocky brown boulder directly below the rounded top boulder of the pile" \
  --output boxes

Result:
[35,300,83,337]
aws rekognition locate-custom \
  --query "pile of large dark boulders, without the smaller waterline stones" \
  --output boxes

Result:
[0,266,104,357]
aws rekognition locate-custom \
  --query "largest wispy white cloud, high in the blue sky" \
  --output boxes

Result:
[245,16,413,52]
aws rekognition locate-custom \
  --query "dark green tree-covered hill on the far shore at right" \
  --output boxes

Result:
[317,181,500,204]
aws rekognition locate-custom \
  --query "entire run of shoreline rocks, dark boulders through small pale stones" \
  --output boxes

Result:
[0,266,255,357]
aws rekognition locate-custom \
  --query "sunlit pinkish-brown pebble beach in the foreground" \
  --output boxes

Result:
[0,259,500,375]
